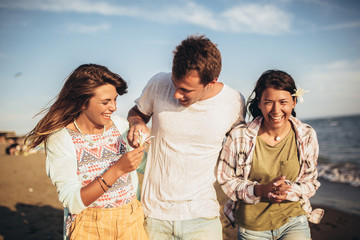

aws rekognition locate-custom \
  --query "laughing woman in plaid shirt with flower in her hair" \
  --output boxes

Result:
[217,70,324,240]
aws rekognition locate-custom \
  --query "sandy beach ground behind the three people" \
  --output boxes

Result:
[0,146,360,240]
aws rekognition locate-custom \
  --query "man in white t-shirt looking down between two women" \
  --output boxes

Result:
[128,36,246,240]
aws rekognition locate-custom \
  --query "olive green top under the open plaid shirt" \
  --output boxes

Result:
[235,129,305,231]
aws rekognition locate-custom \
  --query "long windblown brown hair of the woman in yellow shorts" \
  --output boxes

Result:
[25,64,127,149]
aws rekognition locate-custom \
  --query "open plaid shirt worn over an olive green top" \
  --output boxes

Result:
[217,116,324,226]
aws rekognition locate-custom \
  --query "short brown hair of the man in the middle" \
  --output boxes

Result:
[172,35,221,86]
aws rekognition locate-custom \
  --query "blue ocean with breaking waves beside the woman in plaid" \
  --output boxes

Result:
[302,115,360,188]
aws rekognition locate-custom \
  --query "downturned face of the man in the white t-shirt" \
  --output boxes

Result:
[172,72,209,107]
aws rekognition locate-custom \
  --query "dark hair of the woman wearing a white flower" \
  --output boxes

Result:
[246,70,296,118]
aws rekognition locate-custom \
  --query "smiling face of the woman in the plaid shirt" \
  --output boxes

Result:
[259,88,296,130]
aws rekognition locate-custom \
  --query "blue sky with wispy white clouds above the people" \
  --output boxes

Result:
[0,0,360,135]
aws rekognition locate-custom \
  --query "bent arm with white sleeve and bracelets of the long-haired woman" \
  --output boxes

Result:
[46,130,144,214]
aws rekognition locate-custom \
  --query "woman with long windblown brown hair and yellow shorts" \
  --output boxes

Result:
[27,64,147,240]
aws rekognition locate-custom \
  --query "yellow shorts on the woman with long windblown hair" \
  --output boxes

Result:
[69,199,148,240]
